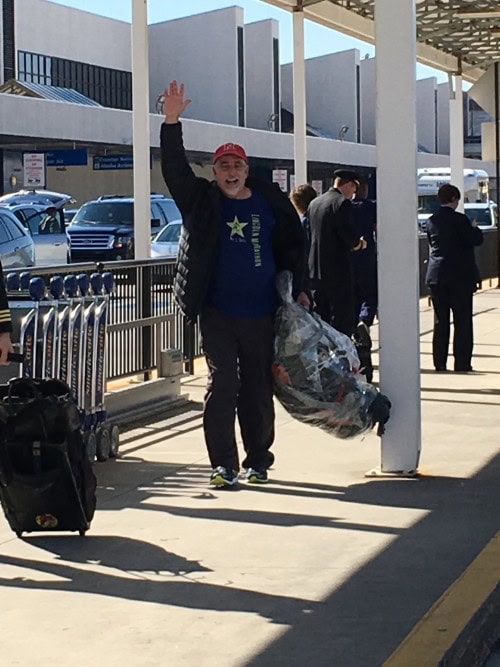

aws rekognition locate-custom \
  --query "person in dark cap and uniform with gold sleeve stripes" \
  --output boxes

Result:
[307,169,366,336]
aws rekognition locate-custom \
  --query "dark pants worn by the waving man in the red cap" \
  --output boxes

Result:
[200,308,274,471]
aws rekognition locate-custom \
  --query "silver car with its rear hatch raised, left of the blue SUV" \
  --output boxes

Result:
[0,201,68,266]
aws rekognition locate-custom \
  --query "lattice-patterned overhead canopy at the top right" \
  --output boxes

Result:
[265,0,500,82]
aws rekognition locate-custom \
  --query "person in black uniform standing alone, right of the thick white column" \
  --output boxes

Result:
[426,184,483,373]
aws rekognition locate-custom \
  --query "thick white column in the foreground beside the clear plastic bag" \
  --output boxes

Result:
[375,0,420,474]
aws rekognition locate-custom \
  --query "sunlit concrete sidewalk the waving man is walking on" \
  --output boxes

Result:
[0,289,500,667]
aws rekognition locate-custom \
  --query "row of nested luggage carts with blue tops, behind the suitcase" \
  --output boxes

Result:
[0,272,120,461]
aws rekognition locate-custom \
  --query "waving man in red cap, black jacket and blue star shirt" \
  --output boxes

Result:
[161,81,309,487]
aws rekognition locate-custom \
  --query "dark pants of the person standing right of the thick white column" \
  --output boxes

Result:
[429,284,473,371]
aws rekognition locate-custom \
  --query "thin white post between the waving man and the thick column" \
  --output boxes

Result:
[293,7,307,185]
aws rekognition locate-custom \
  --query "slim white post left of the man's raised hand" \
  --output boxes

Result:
[132,0,151,259]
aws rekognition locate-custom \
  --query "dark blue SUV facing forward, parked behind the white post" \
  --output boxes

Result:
[66,194,181,262]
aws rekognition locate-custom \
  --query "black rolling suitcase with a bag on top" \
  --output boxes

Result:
[0,379,96,537]
